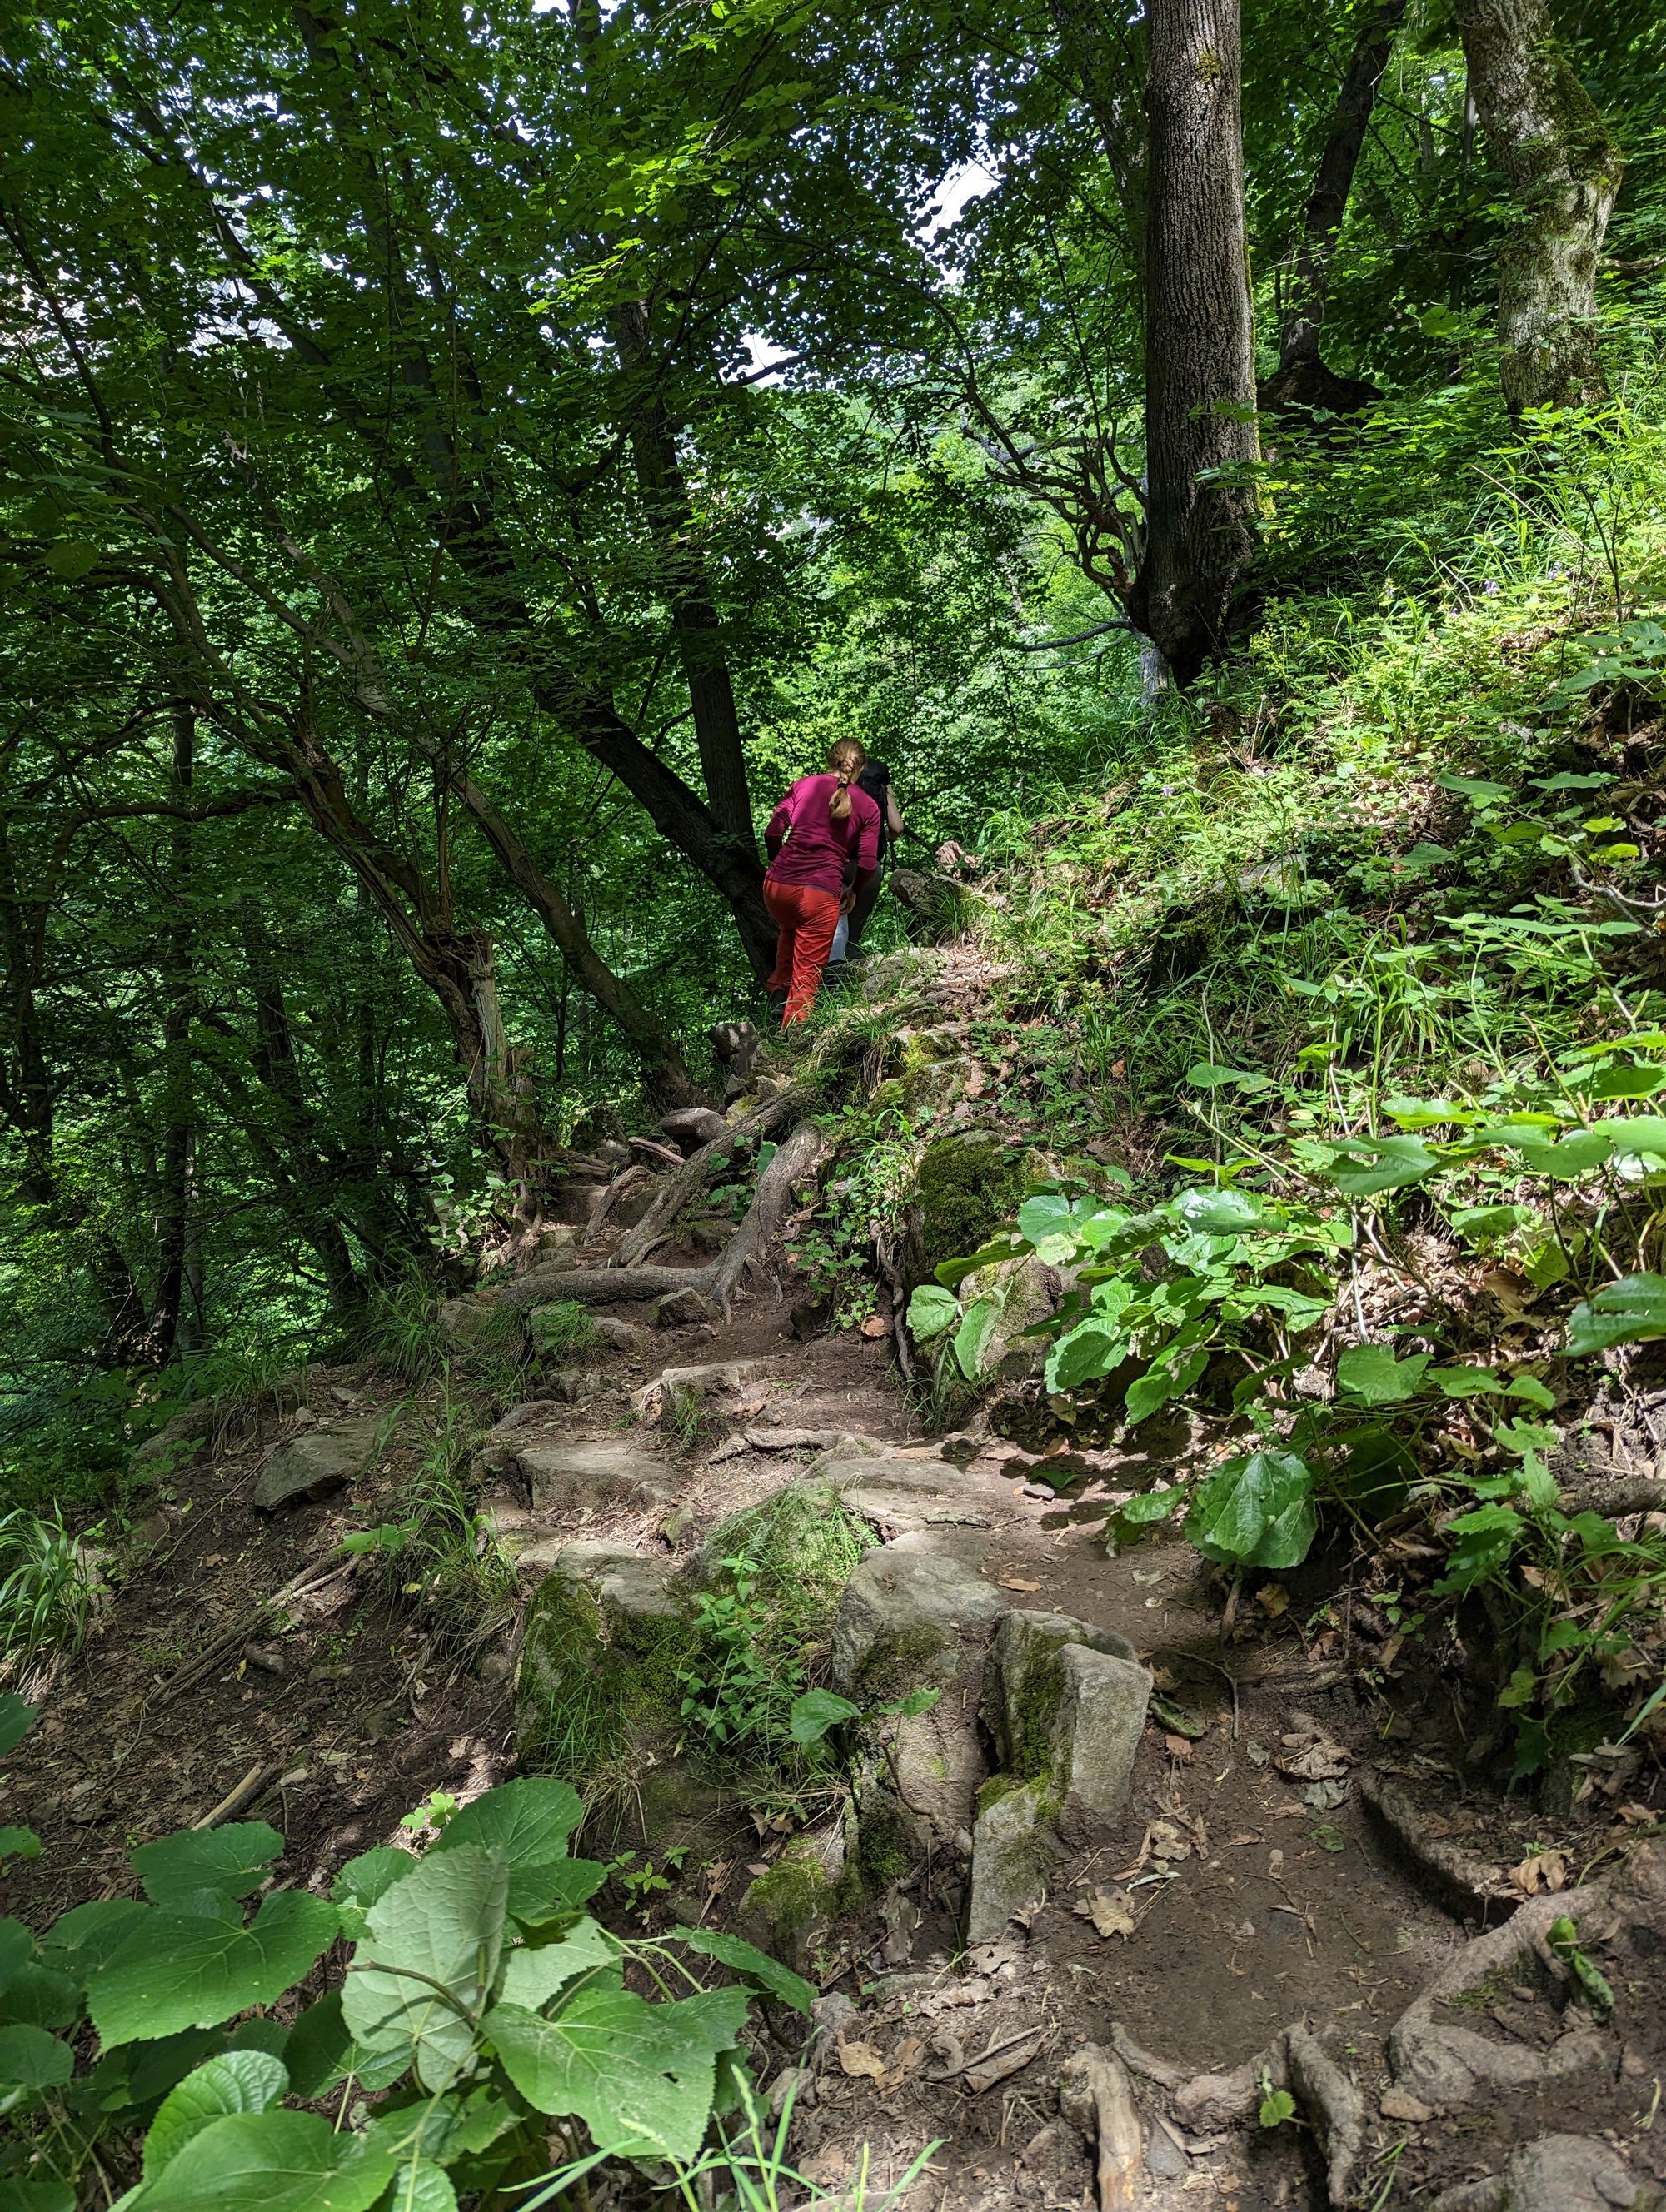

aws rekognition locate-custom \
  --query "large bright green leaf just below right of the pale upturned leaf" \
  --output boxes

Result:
[485,1989,748,2164]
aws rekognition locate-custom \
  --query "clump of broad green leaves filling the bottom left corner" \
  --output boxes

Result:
[0,1712,814,2212]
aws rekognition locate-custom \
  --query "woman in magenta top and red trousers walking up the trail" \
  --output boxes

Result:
[763,736,880,1029]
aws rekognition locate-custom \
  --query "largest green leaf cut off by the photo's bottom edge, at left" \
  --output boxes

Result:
[124,2105,394,2212]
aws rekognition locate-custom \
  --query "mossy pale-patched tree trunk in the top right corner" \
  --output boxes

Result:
[1458,0,1624,416]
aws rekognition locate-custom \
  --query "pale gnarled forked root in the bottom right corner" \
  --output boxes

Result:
[1389,1882,1609,2108]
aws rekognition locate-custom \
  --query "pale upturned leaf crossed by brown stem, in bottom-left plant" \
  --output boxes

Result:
[341,1842,509,2090]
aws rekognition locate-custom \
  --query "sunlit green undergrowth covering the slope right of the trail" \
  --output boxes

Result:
[787,418,1666,1774]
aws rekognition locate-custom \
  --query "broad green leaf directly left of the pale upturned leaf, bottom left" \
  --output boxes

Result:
[87,1889,341,2050]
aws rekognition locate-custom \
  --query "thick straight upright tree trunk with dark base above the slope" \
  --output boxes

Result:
[1129,0,1259,688]
